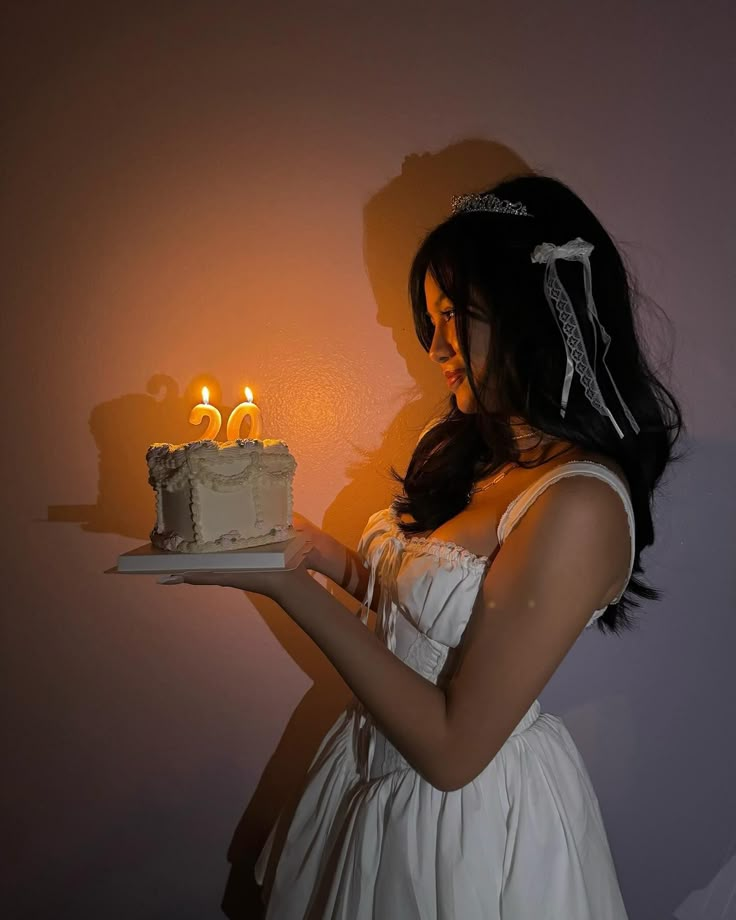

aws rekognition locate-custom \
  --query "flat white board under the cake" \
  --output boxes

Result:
[105,533,312,575]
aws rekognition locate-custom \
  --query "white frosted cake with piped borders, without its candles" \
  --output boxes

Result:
[146,438,296,553]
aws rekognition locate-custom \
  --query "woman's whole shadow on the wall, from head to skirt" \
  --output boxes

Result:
[222,139,529,920]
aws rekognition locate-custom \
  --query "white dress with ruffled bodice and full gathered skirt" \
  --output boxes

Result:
[255,460,634,920]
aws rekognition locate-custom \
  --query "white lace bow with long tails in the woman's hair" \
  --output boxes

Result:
[532,236,639,438]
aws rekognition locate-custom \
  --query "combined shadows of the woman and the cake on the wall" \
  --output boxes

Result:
[48,139,528,920]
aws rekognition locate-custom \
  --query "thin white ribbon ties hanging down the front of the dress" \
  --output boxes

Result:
[353,537,402,782]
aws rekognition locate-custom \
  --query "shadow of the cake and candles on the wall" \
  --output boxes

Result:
[47,374,236,541]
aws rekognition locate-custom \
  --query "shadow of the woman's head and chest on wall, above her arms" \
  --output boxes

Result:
[323,139,529,547]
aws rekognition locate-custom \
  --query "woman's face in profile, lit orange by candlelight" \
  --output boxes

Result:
[424,272,491,415]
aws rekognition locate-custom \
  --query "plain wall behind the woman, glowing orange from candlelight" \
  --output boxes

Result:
[2,2,734,918]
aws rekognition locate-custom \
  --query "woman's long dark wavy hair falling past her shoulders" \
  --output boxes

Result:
[391,173,683,633]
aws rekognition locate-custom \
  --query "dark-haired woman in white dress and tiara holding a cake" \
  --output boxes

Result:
[167,175,682,920]
